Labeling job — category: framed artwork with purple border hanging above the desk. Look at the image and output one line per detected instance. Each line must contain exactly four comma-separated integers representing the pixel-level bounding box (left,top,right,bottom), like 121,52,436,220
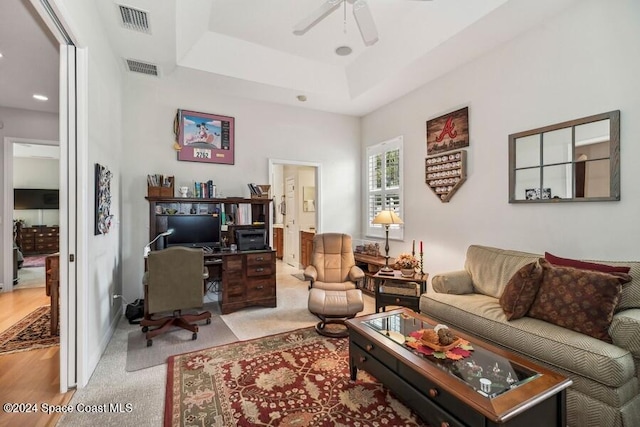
175,110,235,165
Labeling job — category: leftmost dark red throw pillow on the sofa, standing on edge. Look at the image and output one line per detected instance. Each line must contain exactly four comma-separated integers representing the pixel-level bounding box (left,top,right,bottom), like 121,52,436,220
500,261,543,320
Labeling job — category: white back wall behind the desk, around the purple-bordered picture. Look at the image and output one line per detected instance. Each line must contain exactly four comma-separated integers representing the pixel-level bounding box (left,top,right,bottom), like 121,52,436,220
121,69,361,300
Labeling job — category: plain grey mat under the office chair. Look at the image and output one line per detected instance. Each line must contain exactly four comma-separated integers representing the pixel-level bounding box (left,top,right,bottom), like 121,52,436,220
125,315,238,372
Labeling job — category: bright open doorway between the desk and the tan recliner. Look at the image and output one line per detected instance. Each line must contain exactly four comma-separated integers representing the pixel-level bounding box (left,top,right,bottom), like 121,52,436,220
269,159,322,269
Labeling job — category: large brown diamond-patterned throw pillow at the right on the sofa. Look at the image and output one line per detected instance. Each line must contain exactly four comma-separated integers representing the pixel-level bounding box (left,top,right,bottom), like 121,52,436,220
528,259,624,342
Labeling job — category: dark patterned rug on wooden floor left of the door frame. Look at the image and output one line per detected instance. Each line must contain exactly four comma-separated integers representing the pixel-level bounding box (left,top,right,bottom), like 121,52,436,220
0,305,60,355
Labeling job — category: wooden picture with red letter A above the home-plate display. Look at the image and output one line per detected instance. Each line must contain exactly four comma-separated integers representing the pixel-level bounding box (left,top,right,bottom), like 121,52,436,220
427,107,469,156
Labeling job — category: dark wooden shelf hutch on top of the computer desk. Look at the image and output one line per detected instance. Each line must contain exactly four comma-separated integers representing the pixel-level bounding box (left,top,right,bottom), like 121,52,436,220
146,197,273,249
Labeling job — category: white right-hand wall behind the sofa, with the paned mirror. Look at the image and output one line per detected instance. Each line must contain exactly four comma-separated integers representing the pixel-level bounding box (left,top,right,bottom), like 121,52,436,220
362,0,640,275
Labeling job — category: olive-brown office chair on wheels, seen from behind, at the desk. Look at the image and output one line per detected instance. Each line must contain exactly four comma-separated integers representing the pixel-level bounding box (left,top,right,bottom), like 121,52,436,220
140,246,211,346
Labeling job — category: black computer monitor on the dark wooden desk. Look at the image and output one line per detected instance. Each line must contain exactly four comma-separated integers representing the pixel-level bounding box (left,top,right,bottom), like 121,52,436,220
165,215,220,248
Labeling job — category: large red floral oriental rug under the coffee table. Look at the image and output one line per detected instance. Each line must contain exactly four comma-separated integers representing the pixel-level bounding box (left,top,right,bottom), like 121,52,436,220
164,328,424,426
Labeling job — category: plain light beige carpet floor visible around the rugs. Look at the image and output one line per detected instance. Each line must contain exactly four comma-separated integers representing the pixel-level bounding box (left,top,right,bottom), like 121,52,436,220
58,261,375,427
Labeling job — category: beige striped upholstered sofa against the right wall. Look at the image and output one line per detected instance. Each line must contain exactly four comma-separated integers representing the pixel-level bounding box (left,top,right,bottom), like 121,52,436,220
420,245,640,427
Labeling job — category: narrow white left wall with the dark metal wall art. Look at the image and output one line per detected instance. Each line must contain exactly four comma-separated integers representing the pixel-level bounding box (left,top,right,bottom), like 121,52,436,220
55,0,124,387
